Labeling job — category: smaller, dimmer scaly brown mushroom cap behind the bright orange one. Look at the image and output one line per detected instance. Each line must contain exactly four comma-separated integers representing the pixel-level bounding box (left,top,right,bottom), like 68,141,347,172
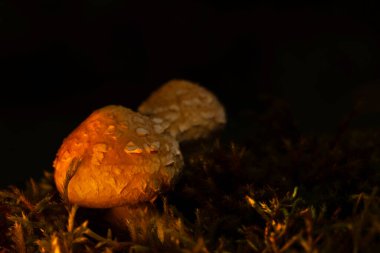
138,79,226,142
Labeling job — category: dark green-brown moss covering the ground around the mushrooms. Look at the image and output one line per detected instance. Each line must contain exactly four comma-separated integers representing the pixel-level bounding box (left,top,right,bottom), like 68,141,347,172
0,98,380,253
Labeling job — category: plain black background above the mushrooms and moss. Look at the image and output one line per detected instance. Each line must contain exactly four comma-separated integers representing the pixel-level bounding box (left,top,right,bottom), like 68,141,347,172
0,0,380,187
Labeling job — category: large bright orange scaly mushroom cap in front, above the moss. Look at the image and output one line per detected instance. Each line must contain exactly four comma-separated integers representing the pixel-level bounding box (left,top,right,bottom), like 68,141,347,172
53,105,183,208
